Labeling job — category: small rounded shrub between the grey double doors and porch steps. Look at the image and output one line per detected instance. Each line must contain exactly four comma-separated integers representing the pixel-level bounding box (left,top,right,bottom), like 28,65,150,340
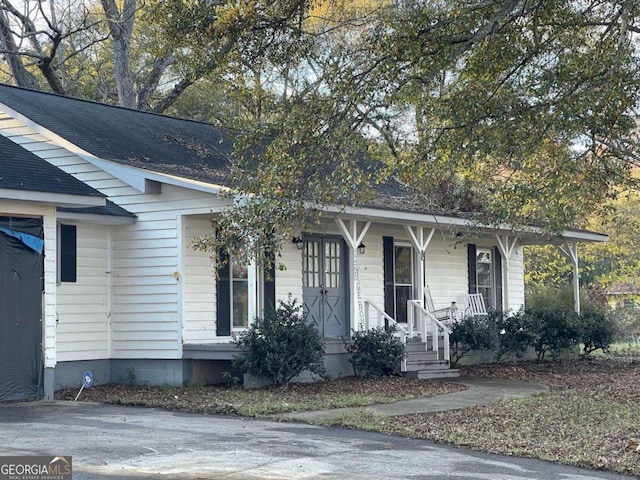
345,327,406,379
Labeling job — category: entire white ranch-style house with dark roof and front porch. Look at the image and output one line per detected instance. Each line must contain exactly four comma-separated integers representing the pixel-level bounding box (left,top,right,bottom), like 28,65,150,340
0,85,606,401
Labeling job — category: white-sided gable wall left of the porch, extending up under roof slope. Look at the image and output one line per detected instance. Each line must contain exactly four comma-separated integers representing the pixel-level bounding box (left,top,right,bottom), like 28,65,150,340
0,114,231,358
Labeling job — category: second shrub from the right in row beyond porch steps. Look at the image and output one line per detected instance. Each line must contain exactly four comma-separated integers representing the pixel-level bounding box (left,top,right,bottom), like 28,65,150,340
525,308,580,361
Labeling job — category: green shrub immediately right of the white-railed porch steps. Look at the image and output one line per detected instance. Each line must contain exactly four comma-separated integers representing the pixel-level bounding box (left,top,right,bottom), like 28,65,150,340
449,316,497,366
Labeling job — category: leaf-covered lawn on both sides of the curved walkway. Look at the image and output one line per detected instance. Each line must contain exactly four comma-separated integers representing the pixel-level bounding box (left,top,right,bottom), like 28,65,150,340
57,353,640,476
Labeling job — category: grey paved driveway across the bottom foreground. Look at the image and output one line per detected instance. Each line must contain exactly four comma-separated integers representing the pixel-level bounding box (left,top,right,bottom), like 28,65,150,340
0,402,630,480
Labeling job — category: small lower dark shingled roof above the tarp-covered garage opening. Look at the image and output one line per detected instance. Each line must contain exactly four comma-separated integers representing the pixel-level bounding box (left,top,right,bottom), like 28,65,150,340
0,135,104,197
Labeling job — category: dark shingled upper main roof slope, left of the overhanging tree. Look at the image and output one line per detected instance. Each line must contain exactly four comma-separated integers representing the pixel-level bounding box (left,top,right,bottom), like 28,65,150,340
0,84,233,185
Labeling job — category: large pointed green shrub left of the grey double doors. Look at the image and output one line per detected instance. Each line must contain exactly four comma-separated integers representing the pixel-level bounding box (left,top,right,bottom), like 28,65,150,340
233,297,325,386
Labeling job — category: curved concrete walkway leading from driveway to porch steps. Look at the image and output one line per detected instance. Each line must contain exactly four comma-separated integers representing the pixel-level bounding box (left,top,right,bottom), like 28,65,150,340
273,378,549,423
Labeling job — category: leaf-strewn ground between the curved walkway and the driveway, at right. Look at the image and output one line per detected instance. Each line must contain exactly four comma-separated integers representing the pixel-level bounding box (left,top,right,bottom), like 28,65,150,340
370,359,640,475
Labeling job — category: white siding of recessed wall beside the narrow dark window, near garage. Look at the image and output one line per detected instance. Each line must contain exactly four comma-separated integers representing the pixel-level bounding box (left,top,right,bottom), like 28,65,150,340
56,224,110,361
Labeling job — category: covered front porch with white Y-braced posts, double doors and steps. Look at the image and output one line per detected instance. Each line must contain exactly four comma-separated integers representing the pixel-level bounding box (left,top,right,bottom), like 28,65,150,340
182,209,606,382
